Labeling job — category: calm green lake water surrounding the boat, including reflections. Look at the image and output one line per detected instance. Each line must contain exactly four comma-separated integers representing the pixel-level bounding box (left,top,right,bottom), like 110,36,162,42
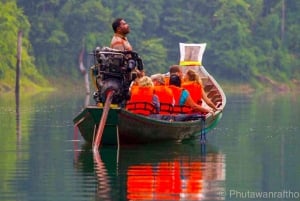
0,90,300,201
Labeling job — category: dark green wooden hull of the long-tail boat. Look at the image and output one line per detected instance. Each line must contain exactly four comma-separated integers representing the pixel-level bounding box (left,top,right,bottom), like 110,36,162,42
74,106,221,145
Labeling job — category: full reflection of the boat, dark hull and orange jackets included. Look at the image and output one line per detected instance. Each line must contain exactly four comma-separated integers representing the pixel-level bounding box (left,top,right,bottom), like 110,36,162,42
75,144,225,200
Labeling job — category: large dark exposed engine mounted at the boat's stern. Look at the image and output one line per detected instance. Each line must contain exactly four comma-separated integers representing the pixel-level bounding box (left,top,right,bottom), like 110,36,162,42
91,47,143,107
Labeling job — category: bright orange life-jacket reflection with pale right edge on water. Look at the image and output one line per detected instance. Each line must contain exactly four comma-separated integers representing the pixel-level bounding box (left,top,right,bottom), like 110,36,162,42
127,154,225,200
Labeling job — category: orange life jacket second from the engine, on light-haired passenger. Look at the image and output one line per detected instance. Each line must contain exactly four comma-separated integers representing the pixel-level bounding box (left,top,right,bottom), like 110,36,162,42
154,86,174,114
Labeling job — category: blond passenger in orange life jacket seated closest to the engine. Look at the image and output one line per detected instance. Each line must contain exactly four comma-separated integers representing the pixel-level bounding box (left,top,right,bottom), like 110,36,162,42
126,76,160,115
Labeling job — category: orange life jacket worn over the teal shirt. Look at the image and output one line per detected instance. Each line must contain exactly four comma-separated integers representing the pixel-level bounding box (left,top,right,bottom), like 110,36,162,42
169,85,192,114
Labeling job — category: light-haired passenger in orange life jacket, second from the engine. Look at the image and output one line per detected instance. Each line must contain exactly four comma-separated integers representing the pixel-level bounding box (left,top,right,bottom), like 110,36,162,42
151,74,175,114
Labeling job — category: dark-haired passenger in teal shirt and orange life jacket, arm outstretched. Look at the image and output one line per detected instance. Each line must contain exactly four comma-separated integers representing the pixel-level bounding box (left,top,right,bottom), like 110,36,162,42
169,65,214,114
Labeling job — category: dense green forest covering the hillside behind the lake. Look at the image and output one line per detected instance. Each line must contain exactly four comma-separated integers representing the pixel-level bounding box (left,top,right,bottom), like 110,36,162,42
0,0,300,93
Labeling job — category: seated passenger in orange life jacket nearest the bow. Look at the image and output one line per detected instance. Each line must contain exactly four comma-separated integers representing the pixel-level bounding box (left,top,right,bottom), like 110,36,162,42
181,69,217,110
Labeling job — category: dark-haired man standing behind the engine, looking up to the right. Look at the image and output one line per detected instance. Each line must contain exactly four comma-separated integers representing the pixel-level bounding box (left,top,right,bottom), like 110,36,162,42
110,18,132,51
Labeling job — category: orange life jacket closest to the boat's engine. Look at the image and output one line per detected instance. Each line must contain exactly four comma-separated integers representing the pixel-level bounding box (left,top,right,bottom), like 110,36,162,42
126,86,156,115
